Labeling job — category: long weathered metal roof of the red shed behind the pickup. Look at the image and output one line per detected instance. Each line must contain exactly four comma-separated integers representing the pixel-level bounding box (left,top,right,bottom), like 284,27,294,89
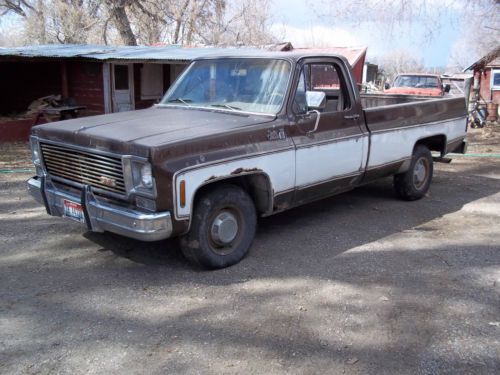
0,44,366,65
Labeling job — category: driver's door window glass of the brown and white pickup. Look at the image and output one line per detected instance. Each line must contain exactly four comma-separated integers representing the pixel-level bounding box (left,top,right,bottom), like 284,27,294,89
310,63,351,112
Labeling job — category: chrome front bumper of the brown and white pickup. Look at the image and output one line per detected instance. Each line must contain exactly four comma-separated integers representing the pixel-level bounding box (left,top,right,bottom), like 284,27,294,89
28,176,172,241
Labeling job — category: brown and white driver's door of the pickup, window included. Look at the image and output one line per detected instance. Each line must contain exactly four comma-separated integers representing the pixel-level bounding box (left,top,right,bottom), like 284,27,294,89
291,58,368,204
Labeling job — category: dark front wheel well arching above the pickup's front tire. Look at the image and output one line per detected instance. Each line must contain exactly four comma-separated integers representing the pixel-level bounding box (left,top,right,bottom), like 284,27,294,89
194,173,273,214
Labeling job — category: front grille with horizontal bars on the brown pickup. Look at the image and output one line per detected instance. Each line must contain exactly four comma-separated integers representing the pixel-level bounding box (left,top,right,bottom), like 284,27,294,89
40,143,126,195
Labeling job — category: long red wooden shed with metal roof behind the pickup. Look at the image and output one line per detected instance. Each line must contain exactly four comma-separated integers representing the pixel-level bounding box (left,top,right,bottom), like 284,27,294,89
0,43,366,142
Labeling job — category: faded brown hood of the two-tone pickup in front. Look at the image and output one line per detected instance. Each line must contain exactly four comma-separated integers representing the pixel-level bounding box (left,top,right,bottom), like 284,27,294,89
32,107,274,156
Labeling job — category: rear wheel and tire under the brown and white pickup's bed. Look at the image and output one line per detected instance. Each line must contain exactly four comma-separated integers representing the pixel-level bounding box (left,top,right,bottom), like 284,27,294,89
394,145,433,201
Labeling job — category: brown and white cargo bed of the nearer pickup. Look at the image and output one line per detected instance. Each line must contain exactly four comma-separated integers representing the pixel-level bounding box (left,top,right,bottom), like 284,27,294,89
362,95,467,175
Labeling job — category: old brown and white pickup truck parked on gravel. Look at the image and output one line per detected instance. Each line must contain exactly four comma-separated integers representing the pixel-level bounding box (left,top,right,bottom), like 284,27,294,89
28,52,467,268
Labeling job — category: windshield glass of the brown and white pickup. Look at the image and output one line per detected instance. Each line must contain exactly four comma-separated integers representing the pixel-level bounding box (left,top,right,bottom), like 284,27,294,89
161,58,291,114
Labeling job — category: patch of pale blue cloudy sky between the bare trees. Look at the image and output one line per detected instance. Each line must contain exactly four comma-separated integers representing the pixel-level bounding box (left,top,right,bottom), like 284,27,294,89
271,0,460,67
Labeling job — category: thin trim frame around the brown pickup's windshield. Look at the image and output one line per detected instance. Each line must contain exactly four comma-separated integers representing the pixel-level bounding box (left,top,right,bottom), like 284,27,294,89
160,56,294,117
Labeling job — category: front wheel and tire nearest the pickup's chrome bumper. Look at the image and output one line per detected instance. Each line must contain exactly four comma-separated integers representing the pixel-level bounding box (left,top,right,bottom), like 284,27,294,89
180,184,257,269
